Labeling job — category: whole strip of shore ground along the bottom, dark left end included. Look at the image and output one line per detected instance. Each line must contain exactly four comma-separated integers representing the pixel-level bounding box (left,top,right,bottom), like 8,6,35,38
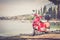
0,34,60,40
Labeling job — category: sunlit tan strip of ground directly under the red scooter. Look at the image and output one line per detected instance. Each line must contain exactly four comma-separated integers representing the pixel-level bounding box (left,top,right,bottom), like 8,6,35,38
20,34,60,39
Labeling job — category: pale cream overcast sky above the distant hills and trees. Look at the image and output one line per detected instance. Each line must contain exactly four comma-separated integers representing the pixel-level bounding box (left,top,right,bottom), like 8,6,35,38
0,0,54,16
